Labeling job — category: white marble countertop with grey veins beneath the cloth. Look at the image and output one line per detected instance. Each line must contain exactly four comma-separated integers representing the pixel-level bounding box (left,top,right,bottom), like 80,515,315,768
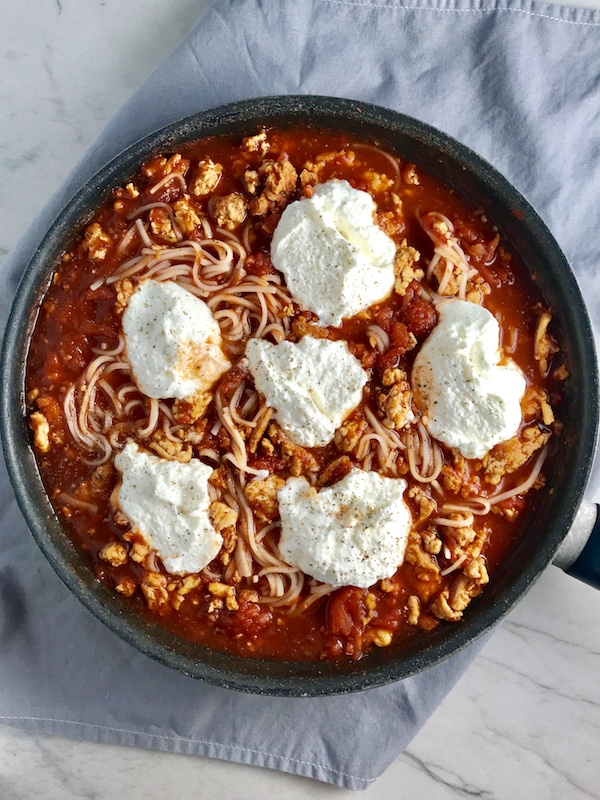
0,0,600,800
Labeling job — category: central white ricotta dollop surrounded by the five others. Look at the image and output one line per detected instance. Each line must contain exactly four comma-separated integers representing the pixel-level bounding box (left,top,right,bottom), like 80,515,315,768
246,336,367,447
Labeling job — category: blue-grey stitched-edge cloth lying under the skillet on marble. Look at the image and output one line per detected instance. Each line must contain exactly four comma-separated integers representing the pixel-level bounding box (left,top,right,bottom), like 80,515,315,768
0,0,600,789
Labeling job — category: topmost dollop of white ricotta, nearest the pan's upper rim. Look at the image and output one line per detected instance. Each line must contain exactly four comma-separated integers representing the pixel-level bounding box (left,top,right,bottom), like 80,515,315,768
271,180,396,325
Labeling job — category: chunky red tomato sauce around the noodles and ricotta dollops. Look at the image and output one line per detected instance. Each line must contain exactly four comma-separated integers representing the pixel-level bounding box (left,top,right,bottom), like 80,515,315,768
27,129,560,660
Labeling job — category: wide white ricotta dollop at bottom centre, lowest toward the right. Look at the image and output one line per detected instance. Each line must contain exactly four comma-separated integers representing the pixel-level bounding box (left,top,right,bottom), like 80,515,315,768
278,469,412,589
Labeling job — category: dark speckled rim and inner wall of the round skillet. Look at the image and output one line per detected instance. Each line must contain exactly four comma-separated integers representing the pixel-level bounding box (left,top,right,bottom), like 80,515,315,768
0,96,598,696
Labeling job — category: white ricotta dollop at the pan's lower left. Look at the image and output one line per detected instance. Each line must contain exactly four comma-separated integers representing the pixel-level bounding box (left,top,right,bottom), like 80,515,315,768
115,442,223,575
